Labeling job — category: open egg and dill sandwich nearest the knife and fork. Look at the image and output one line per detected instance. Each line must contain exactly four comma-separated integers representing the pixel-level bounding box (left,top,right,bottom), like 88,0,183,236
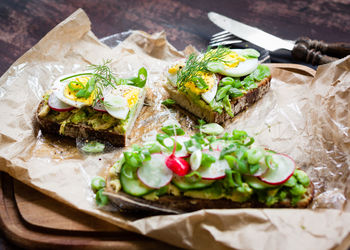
165,47,271,123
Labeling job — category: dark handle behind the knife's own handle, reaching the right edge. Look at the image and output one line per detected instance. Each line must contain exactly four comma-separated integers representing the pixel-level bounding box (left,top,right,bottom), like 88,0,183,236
296,37,350,58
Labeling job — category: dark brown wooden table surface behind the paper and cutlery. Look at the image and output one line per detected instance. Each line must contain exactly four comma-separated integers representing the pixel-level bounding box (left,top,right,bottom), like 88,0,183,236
0,0,350,249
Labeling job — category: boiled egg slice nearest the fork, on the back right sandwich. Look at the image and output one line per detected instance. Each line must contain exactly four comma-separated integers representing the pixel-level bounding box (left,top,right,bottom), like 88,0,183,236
208,49,260,77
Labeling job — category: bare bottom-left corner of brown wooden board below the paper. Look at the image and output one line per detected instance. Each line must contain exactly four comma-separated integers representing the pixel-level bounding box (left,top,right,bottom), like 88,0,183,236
0,173,176,249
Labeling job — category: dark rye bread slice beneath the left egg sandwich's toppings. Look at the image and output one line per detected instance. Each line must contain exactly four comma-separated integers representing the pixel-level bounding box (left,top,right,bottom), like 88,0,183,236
36,90,146,147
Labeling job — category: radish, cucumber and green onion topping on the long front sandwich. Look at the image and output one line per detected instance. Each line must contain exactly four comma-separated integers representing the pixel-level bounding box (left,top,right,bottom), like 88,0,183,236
111,122,310,206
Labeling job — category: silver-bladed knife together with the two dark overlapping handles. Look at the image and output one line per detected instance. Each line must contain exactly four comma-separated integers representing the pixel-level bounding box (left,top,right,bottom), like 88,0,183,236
208,12,350,65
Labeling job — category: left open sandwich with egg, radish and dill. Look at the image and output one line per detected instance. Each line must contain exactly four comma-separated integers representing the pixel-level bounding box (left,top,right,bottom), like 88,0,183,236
37,63,147,146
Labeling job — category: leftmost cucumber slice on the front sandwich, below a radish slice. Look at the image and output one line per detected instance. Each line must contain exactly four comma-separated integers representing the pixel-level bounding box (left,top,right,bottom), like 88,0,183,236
120,165,153,196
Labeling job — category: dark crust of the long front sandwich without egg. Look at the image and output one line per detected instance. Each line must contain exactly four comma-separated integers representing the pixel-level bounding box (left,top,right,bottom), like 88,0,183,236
106,183,314,213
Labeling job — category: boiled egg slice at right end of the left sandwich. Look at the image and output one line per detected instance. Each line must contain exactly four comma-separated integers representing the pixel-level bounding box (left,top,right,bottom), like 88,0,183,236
103,85,141,120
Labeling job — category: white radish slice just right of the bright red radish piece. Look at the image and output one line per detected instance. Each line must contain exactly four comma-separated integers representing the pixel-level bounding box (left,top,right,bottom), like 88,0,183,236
197,151,230,180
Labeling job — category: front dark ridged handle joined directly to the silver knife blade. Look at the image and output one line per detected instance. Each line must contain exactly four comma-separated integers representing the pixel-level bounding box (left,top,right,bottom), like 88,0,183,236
292,43,338,65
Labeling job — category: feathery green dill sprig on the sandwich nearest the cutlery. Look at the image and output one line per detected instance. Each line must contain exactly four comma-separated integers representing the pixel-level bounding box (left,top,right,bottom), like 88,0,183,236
177,47,230,91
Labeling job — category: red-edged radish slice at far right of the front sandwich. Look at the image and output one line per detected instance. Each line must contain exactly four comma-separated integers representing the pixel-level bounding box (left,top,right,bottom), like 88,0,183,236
258,154,295,185
